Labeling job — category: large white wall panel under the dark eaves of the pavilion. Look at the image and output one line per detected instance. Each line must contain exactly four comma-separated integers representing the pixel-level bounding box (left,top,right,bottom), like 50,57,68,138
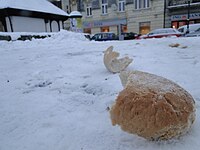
10,16,46,32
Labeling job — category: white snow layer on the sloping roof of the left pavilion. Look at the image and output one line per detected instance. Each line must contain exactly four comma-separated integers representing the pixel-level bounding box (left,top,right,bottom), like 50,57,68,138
0,0,69,16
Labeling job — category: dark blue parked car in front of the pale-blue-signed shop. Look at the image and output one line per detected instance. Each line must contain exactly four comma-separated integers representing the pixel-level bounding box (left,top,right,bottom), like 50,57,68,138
91,32,118,41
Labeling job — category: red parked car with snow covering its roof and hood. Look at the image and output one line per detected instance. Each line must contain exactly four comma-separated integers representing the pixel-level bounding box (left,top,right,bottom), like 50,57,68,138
138,28,183,39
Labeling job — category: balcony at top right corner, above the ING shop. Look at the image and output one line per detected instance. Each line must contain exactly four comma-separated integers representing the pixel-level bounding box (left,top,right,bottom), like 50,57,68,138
168,0,200,9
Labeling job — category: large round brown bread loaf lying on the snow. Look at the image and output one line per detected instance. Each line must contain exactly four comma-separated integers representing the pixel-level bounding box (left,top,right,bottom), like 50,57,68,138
110,71,195,140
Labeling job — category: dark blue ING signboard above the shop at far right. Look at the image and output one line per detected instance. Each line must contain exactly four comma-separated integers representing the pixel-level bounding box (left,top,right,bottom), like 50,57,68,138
171,13,200,21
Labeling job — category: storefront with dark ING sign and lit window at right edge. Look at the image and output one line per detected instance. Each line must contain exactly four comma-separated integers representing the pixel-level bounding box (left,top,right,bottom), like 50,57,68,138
171,13,200,28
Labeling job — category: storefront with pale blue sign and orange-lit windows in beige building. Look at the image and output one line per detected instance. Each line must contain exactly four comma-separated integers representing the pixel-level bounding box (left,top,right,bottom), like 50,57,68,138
83,19,127,34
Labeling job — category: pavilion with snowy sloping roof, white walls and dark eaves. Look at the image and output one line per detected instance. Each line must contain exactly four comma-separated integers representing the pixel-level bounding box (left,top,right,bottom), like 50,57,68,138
0,0,69,32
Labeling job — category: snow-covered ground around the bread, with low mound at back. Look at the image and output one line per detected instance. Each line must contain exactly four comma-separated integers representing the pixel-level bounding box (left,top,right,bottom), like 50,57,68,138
0,31,200,150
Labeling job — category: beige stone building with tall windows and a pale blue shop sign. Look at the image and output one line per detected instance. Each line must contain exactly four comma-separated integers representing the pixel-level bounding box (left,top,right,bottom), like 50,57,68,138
69,0,164,34
